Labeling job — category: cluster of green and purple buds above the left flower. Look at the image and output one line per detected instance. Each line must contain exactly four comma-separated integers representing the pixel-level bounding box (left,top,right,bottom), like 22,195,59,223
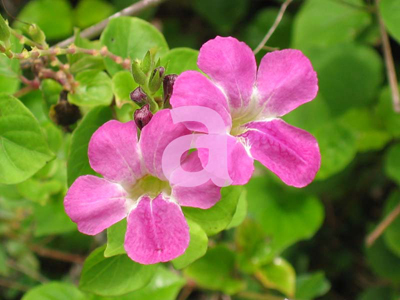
130,49,177,129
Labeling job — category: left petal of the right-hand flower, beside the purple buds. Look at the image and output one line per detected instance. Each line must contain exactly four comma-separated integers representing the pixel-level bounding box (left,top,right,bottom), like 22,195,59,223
170,71,232,132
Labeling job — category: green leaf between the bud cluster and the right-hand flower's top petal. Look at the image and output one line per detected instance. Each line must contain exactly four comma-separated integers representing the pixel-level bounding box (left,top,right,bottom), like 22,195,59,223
161,48,200,75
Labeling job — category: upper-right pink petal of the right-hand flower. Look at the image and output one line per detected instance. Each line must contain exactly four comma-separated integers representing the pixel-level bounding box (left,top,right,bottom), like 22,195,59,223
257,49,318,117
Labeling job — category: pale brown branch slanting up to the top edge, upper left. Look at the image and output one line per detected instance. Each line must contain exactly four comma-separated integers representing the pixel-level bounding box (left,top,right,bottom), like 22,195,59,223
56,0,165,47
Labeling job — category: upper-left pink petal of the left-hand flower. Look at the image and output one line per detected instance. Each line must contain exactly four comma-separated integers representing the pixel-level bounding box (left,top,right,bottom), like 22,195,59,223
88,120,144,184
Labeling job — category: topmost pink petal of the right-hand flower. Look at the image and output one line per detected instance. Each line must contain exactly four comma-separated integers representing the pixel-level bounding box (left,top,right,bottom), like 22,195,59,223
197,36,257,109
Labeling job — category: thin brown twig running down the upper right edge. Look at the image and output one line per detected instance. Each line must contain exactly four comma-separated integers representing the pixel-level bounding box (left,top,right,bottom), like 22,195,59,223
375,0,400,113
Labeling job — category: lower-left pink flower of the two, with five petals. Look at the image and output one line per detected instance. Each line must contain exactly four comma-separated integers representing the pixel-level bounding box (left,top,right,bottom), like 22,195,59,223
64,110,221,264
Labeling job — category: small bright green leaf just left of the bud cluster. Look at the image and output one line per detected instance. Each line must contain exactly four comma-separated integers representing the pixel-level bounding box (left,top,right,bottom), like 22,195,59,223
112,71,138,107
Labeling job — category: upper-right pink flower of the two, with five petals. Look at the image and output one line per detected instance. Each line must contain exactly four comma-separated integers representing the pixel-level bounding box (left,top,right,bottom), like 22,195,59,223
170,37,321,187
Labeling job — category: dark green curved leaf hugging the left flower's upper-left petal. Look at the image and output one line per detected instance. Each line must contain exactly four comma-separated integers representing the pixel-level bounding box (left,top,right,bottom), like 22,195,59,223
67,107,112,186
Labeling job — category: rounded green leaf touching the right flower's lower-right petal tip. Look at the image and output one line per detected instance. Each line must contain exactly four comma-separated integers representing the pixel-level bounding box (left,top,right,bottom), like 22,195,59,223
314,121,357,179
